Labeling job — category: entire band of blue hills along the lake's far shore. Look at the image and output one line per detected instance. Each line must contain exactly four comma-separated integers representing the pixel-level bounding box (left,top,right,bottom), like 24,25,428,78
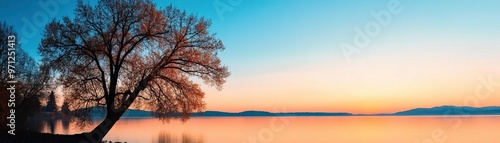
71,106,500,118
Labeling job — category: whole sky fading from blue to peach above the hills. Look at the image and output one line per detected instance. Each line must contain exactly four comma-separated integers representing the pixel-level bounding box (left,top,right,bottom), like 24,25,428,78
0,0,500,113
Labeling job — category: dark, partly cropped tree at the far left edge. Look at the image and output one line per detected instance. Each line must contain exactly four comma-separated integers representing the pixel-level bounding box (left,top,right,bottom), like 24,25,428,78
0,22,49,130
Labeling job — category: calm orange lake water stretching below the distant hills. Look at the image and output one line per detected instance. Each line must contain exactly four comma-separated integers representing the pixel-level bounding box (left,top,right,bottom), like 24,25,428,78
42,116,500,143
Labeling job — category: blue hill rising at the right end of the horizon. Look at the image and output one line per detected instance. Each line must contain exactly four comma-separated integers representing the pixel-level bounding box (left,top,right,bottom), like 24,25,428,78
392,106,500,115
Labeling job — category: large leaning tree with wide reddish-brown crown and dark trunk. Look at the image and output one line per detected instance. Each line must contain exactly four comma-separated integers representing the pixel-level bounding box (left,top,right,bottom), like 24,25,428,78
39,0,230,140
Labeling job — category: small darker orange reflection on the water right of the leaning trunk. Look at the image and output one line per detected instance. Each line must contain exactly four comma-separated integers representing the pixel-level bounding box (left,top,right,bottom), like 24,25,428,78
153,130,204,143
